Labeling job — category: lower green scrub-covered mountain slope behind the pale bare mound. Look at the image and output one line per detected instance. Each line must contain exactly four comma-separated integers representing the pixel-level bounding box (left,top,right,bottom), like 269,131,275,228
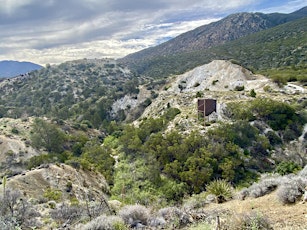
120,17,307,78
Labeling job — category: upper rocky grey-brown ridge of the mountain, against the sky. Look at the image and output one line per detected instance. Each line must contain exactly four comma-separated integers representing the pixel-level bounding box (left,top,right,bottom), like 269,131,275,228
124,7,307,61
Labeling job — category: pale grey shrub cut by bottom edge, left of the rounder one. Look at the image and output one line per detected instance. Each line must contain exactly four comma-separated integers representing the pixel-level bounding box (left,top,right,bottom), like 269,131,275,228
82,215,128,230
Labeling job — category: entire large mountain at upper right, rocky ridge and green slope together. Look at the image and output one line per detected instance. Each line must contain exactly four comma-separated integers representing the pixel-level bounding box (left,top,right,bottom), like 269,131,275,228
120,8,306,78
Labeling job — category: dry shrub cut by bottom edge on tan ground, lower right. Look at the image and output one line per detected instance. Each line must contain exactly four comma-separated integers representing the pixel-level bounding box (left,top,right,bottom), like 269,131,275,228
222,212,272,230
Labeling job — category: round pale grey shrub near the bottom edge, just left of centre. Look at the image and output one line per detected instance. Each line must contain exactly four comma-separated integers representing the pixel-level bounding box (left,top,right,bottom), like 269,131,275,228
119,204,150,227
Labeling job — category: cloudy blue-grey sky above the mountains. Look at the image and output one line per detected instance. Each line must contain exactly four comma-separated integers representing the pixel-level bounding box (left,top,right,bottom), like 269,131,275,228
0,0,307,65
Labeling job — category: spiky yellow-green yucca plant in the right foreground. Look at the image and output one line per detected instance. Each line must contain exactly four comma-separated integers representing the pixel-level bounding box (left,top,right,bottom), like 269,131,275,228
206,179,233,203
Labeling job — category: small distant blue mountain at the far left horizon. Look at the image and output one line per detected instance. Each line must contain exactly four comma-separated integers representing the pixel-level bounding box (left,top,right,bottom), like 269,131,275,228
0,61,42,78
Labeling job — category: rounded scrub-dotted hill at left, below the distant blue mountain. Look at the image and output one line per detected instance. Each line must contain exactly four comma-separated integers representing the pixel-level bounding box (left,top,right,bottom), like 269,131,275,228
0,59,153,128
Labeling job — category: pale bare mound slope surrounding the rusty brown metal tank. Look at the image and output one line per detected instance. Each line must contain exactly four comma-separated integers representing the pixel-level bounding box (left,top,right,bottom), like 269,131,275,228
140,60,307,132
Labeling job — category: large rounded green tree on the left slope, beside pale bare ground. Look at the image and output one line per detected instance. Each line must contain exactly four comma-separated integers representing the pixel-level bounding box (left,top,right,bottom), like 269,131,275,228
31,118,65,153
